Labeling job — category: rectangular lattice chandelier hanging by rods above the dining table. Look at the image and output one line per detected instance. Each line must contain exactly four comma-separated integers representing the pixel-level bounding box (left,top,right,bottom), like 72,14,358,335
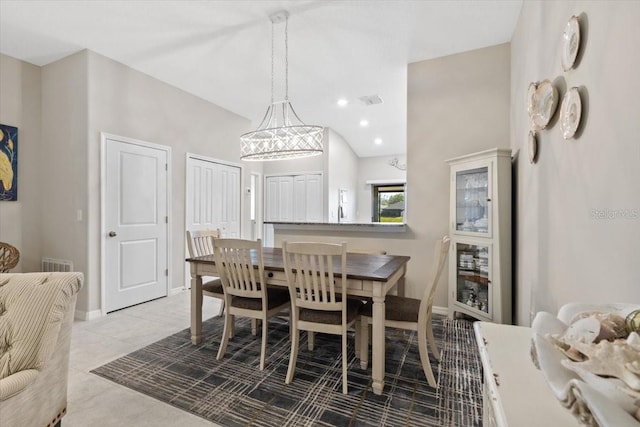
240,11,324,161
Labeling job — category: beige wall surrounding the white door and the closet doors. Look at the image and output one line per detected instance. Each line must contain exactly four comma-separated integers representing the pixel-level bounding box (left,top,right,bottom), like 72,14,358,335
85,52,255,311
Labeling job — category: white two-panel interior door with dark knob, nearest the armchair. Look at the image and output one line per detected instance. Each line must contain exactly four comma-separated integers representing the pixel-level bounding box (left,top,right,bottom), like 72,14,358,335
102,136,169,312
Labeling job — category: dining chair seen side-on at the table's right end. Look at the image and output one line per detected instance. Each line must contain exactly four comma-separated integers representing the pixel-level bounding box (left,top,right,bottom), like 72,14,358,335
360,236,451,388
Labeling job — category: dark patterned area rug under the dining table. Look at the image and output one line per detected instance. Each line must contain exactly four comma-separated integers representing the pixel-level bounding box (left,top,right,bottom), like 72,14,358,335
92,316,482,427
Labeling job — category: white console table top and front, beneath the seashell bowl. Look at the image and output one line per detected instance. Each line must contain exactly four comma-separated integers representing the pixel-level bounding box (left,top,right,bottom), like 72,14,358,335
473,322,579,427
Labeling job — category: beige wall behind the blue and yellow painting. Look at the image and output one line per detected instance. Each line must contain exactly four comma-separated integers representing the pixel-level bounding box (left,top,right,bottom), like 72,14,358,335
0,55,41,271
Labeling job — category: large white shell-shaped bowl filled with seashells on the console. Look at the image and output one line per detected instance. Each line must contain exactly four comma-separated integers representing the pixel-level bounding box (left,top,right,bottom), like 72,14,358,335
531,303,640,427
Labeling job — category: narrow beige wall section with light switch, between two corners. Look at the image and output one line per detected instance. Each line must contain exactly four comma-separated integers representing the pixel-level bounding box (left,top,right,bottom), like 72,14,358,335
39,54,90,307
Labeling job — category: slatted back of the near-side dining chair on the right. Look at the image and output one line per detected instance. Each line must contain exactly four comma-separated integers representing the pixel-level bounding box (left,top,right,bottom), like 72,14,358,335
282,241,347,317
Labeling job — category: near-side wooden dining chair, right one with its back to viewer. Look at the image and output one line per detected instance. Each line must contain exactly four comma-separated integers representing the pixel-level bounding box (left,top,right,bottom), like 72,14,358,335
282,241,363,394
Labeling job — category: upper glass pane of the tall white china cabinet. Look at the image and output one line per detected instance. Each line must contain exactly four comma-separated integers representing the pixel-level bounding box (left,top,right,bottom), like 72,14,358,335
455,166,491,235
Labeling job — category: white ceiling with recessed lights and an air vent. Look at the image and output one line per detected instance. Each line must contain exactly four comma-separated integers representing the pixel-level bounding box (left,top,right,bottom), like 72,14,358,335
0,0,522,157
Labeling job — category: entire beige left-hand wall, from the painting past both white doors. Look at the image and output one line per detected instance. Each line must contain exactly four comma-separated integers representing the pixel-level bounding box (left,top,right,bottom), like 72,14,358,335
0,51,262,316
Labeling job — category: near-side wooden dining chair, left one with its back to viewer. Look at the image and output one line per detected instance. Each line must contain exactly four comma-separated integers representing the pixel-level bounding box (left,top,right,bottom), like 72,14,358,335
213,239,290,371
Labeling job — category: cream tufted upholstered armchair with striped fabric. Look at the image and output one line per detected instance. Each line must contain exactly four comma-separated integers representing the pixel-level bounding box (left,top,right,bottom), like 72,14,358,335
0,273,83,427
